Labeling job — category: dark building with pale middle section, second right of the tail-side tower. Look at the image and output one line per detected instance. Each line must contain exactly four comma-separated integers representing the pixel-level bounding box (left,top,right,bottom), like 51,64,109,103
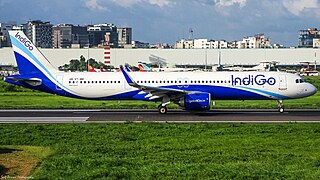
87,24,118,48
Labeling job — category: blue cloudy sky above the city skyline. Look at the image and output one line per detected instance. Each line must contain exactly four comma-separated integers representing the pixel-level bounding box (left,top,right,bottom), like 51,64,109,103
0,0,320,46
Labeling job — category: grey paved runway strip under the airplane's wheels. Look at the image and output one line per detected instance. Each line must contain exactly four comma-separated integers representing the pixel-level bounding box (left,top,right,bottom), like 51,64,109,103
0,109,320,123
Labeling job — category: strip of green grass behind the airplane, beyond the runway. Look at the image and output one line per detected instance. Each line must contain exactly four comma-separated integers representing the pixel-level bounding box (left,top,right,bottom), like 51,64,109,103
0,77,320,109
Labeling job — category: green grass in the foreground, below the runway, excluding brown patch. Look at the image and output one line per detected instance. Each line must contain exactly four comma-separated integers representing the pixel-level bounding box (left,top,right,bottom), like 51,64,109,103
0,123,320,179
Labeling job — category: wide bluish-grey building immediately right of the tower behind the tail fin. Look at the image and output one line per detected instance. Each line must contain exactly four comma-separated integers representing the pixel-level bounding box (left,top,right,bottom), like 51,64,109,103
53,24,89,48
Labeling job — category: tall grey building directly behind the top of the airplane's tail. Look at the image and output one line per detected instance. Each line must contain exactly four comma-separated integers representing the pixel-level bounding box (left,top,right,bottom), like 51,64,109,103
25,20,53,48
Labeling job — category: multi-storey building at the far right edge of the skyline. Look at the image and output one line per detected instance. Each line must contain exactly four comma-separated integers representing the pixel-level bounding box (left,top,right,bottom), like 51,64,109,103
298,28,320,48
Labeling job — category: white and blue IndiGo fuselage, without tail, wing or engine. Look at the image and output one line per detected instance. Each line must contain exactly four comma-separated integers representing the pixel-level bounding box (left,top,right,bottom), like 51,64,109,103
56,72,316,100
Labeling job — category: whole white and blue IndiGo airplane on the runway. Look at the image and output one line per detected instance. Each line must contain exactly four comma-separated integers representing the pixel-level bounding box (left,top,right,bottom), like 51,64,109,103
5,31,317,114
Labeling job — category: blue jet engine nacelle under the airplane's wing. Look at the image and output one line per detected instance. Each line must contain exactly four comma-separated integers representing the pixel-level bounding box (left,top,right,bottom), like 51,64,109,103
179,93,211,111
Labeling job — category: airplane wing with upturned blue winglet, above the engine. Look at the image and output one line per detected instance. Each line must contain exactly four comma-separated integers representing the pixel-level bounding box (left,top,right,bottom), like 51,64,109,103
120,66,194,100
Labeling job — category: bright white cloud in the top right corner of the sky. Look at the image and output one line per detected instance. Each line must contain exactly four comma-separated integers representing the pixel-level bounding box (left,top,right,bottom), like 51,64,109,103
282,0,320,16
